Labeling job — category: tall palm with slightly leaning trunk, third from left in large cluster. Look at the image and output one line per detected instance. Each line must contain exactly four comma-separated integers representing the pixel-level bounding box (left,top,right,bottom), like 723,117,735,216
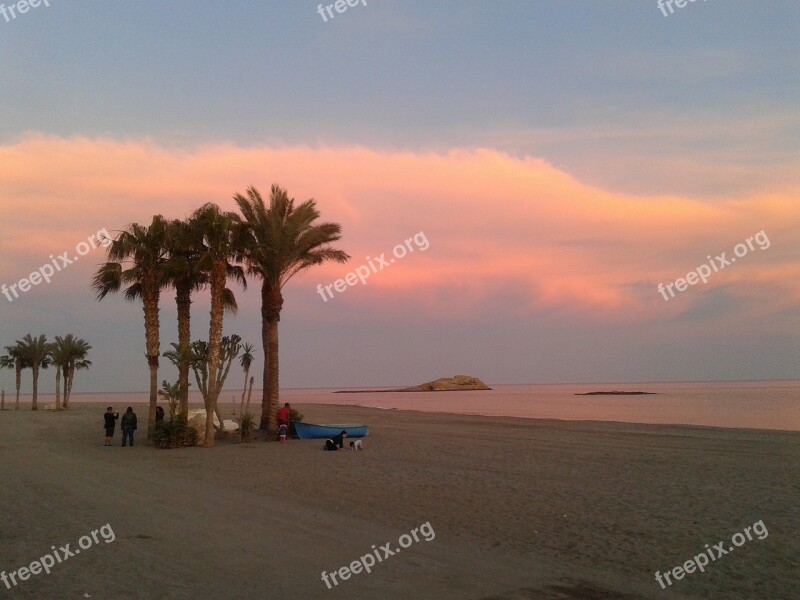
190,203,247,447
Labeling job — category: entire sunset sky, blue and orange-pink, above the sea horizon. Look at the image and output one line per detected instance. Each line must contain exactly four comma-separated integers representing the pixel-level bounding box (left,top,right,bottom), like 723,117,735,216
0,0,800,394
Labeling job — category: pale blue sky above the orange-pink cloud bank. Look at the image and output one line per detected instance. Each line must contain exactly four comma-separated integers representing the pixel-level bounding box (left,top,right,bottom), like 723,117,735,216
0,0,800,193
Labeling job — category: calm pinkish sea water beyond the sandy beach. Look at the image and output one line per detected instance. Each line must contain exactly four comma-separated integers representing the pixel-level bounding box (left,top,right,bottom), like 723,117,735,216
26,381,800,431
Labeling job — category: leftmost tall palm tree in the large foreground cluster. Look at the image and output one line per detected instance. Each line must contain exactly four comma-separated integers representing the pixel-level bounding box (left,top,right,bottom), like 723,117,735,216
92,215,168,444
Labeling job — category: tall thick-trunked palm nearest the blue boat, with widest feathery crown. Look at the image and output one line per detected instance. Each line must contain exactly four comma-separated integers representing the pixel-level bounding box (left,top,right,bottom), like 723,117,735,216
234,185,350,434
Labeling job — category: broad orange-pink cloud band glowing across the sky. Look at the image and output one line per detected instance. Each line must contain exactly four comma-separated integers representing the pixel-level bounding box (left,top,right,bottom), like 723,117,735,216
0,134,800,320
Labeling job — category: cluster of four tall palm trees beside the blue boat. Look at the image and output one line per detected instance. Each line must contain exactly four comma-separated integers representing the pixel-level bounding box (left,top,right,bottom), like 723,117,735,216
92,185,350,446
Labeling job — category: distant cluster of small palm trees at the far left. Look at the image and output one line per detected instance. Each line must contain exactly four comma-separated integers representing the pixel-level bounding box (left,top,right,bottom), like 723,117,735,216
0,333,92,410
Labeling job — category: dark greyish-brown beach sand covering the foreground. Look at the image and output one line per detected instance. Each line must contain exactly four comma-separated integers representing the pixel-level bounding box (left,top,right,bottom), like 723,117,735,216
0,404,800,600
